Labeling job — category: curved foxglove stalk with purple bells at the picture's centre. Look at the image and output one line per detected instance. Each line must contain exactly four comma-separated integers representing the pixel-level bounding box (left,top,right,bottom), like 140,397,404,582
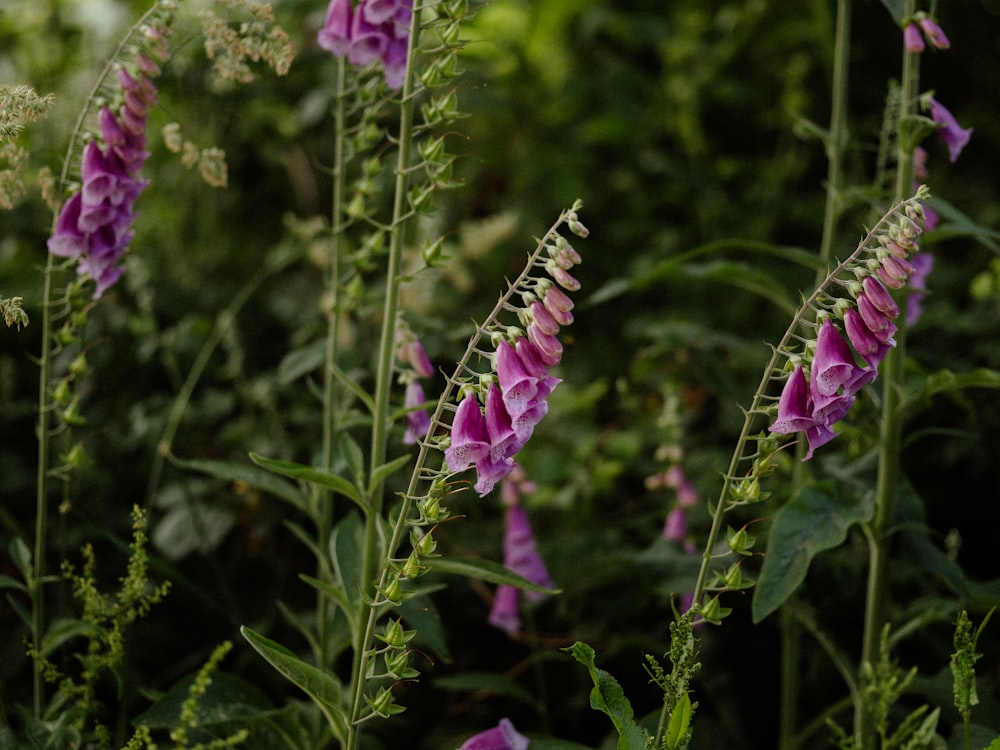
347,202,588,747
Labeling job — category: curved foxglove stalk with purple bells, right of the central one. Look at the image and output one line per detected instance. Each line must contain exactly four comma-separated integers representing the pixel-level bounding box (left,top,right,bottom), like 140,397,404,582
694,187,928,623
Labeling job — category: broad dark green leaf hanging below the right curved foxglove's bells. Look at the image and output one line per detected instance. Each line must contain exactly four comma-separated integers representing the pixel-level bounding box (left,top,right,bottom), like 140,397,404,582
752,482,873,623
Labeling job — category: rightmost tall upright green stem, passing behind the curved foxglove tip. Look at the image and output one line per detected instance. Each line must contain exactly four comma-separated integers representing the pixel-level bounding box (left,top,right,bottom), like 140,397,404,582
854,0,919,748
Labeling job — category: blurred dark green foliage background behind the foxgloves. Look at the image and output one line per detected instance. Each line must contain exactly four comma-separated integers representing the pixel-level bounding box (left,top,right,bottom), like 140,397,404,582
0,0,1000,748
